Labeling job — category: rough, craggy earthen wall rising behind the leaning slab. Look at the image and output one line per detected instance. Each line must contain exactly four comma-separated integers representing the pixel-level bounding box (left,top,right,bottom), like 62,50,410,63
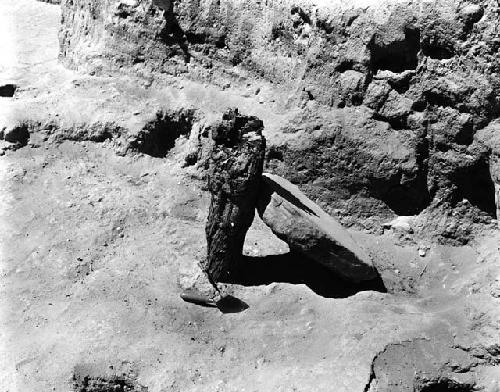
60,0,500,242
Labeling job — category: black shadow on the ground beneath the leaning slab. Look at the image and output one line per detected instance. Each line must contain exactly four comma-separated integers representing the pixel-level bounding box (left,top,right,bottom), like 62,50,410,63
223,252,387,298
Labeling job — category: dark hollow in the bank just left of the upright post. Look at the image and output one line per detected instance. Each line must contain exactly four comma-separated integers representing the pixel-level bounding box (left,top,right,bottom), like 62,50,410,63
130,110,194,158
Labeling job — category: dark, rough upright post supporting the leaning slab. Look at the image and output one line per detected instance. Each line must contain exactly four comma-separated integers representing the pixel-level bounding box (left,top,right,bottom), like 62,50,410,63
202,109,266,284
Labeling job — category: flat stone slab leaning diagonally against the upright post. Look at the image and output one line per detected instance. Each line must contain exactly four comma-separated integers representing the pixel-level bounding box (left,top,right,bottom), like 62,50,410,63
257,173,377,282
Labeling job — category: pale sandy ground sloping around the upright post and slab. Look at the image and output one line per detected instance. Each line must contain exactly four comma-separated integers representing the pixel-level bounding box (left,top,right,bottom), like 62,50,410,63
0,0,500,392
